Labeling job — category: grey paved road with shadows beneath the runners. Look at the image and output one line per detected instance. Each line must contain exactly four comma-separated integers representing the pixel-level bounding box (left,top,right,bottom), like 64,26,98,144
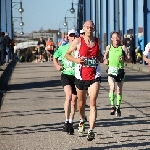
0,63,150,150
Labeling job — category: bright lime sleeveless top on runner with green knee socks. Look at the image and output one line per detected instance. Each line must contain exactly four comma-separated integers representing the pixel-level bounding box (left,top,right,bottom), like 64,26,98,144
108,45,124,75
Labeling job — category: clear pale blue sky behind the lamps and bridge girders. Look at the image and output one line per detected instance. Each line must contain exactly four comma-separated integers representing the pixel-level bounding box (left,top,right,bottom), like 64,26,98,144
12,0,143,33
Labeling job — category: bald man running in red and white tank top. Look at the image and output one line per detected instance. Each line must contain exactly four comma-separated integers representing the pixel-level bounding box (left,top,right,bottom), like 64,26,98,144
66,20,101,141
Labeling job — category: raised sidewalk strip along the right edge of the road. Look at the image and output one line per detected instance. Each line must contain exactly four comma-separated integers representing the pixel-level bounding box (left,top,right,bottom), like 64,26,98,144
125,63,150,73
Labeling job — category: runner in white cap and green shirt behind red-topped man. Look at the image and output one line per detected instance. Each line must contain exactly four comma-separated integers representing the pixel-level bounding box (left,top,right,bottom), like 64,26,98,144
53,29,77,134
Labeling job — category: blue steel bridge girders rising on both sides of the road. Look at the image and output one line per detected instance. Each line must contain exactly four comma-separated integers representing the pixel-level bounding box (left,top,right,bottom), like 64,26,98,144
0,0,150,54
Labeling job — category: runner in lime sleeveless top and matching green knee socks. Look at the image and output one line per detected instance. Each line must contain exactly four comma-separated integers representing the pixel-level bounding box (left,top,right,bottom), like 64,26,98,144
104,31,129,116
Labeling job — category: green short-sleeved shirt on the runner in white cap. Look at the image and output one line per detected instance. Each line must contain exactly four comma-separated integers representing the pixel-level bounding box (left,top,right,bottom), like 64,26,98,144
54,44,75,76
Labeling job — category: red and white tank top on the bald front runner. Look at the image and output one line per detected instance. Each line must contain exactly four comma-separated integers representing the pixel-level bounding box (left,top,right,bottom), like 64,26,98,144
75,37,101,80
